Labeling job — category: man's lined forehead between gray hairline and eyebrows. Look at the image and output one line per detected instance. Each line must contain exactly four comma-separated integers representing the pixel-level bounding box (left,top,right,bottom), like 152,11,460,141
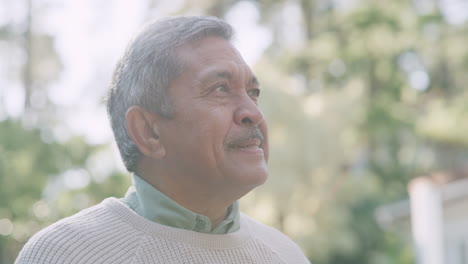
177,36,253,78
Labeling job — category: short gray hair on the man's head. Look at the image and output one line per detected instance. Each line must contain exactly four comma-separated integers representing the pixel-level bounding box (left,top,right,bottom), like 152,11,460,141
107,16,233,172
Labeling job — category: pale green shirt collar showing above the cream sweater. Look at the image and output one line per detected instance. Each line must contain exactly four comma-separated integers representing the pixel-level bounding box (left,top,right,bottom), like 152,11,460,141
122,175,240,234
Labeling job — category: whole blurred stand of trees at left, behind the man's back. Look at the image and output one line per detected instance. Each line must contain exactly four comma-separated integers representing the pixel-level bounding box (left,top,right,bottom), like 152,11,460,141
0,0,130,263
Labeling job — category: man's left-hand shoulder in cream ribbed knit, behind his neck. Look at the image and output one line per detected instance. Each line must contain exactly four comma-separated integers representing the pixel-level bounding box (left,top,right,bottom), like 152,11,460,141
15,198,144,264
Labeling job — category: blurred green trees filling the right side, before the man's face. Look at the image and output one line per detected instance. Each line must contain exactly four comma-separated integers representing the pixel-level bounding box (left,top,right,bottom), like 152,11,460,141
229,0,468,263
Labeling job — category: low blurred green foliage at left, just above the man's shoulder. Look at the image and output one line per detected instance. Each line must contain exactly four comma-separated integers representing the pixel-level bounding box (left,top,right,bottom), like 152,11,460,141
0,119,130,263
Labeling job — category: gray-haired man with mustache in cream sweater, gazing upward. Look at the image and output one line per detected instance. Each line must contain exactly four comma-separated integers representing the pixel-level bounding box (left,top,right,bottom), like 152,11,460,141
17,17,308,264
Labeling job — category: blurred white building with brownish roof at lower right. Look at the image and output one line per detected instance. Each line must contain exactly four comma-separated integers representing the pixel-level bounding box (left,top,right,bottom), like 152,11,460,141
376,170,468,264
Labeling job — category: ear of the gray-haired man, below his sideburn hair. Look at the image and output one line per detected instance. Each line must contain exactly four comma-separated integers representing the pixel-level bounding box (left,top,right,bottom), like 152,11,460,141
125,106,166,159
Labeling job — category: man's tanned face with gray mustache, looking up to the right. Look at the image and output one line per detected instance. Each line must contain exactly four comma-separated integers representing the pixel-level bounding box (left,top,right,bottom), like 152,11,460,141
160,37,268,193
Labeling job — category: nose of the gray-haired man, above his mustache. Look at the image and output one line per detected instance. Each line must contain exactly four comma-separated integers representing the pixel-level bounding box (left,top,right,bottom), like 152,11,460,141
234,95,264,126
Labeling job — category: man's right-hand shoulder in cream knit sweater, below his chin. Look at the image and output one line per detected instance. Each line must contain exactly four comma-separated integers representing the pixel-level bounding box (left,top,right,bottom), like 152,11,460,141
241,213,309,263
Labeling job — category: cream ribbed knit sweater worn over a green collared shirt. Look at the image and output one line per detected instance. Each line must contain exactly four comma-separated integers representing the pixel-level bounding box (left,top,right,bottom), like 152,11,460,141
15,198,309,264
